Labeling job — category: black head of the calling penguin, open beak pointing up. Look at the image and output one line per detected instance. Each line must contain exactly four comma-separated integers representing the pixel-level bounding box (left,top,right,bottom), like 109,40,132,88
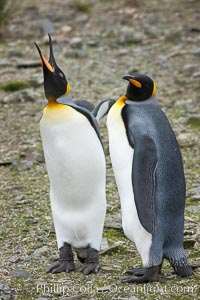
35,34,70,100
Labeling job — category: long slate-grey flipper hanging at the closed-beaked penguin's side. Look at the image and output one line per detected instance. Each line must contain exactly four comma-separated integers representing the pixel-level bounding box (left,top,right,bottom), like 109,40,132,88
132,136,157,233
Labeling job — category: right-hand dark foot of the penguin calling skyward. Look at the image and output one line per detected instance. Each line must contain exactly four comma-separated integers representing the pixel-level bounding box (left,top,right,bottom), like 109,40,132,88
82,247,99,275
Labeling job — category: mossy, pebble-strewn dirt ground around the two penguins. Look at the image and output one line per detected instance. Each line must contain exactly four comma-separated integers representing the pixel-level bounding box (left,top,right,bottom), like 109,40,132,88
0,0,200,300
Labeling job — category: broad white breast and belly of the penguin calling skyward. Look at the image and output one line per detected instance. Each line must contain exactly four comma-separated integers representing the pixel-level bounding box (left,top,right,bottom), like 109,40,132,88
40,107,106,250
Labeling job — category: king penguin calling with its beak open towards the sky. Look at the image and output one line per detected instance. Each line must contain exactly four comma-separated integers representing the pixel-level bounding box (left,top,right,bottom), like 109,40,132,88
35,35,106,275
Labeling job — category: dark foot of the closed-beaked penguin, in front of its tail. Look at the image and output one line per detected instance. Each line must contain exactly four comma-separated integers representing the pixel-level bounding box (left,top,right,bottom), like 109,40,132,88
121,266,160,283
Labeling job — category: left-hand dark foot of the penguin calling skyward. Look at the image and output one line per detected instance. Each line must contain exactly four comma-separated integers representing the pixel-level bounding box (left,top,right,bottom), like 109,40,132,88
47,243,75,274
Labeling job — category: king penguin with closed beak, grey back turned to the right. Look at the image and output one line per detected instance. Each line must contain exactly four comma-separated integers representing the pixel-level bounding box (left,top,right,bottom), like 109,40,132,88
107,74,192,283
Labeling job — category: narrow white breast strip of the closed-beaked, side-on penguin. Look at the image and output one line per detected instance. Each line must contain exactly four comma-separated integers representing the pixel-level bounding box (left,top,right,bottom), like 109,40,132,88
107,104,152,266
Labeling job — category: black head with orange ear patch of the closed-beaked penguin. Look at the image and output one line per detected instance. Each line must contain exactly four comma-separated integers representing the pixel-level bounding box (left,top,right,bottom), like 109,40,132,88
122,74,156,101
